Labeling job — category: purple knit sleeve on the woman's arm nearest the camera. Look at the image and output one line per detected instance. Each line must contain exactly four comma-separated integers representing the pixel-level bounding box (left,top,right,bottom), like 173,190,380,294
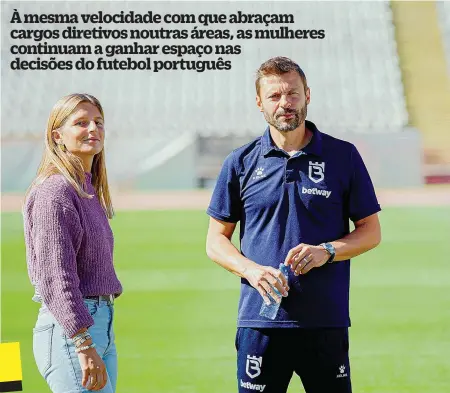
30,189,94,337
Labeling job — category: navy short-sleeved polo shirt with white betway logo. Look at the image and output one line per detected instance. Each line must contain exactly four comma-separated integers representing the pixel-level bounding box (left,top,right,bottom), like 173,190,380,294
207,121,380,328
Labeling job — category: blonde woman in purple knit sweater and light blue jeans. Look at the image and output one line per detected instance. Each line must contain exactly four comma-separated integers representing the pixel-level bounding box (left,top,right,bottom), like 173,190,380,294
24,94,122,393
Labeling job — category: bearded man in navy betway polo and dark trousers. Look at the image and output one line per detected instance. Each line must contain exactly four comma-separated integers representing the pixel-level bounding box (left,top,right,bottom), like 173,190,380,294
207,57,381,393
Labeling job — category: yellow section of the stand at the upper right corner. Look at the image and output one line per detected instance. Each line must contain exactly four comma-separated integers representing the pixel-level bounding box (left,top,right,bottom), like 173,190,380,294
392,2,450,183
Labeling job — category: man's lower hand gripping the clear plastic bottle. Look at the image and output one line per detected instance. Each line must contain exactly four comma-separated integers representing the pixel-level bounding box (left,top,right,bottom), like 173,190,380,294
243,263,289,305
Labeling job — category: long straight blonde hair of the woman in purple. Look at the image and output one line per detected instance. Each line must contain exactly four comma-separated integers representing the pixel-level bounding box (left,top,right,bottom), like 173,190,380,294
27,94,114,218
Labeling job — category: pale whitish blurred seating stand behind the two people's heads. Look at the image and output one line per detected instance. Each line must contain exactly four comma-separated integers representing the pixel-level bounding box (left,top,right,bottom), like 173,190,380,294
2,2,407,136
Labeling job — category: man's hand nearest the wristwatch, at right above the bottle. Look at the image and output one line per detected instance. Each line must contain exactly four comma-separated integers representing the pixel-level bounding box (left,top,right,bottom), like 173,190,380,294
284,243,330,276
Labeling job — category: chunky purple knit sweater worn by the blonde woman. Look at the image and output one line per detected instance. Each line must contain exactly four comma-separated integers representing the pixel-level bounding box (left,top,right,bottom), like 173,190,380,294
24,173,122,337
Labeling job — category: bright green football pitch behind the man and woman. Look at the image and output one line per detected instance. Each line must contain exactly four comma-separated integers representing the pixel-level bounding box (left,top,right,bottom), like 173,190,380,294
1,207,450,393
